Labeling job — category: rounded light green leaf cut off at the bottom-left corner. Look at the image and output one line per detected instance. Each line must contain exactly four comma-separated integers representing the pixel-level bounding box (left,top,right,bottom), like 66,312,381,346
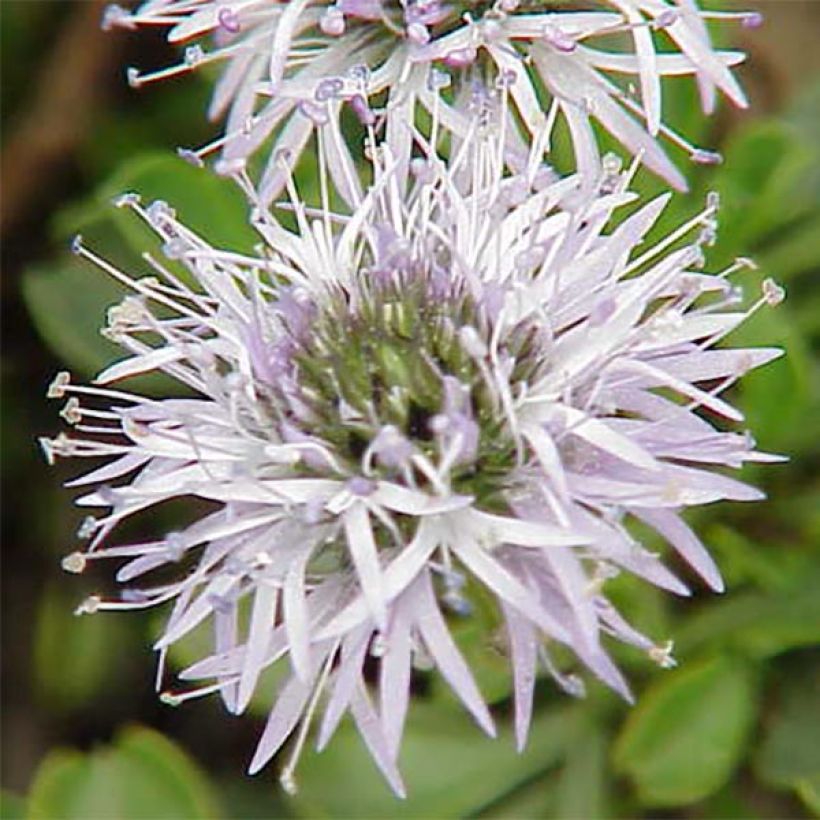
28,726,220,820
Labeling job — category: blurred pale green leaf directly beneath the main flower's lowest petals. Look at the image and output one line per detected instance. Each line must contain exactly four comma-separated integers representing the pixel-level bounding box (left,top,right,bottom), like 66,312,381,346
292,703,576,818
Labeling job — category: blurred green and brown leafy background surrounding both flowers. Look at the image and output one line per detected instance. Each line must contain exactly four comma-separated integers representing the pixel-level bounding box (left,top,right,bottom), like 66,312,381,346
0,0,820,820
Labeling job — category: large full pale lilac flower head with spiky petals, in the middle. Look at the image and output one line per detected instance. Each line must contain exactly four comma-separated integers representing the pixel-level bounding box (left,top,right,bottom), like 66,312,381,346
49,121,783,795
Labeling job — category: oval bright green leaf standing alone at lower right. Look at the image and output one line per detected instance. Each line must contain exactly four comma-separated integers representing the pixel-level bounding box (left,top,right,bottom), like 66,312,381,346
614,658,755,806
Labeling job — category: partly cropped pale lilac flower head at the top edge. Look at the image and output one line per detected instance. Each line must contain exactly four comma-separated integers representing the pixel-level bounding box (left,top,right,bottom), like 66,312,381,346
105,0,759,202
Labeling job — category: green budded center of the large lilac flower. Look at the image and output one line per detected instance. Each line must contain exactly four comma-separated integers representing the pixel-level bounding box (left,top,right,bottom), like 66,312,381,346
294,276,539,507
